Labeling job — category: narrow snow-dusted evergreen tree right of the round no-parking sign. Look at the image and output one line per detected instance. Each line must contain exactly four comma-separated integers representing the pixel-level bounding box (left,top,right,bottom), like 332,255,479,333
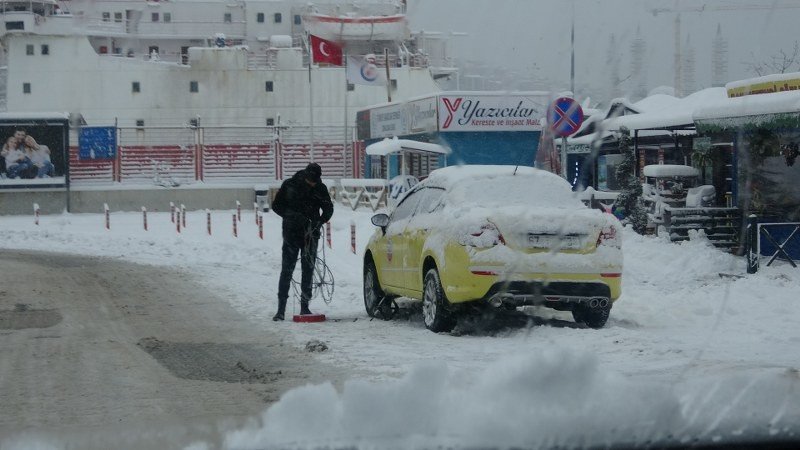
616,127,647,234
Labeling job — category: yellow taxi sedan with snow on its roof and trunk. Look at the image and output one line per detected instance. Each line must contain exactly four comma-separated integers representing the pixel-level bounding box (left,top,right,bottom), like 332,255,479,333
364,165,623,332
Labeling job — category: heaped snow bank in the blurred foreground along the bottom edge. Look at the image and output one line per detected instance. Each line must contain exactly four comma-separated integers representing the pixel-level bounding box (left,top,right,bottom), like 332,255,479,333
224,348,800,449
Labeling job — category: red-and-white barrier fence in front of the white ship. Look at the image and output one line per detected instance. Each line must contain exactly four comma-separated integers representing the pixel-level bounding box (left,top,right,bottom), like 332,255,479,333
69,127,356,186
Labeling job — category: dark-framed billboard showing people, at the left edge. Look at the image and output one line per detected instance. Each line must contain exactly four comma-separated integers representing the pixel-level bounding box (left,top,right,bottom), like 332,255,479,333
0,116,69,188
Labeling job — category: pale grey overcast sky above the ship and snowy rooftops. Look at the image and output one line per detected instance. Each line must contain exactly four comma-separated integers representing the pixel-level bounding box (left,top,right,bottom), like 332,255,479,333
408,0,800,99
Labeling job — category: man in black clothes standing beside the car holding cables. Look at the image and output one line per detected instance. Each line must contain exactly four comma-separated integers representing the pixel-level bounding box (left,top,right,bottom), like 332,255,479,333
272,163,333,321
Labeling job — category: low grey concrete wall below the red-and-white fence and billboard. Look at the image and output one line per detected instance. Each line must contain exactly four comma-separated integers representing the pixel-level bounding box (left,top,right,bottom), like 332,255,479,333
0,187,266,215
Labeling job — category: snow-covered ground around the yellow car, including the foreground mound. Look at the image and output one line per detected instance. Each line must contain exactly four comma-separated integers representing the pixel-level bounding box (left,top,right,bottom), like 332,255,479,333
0,205,800,448
